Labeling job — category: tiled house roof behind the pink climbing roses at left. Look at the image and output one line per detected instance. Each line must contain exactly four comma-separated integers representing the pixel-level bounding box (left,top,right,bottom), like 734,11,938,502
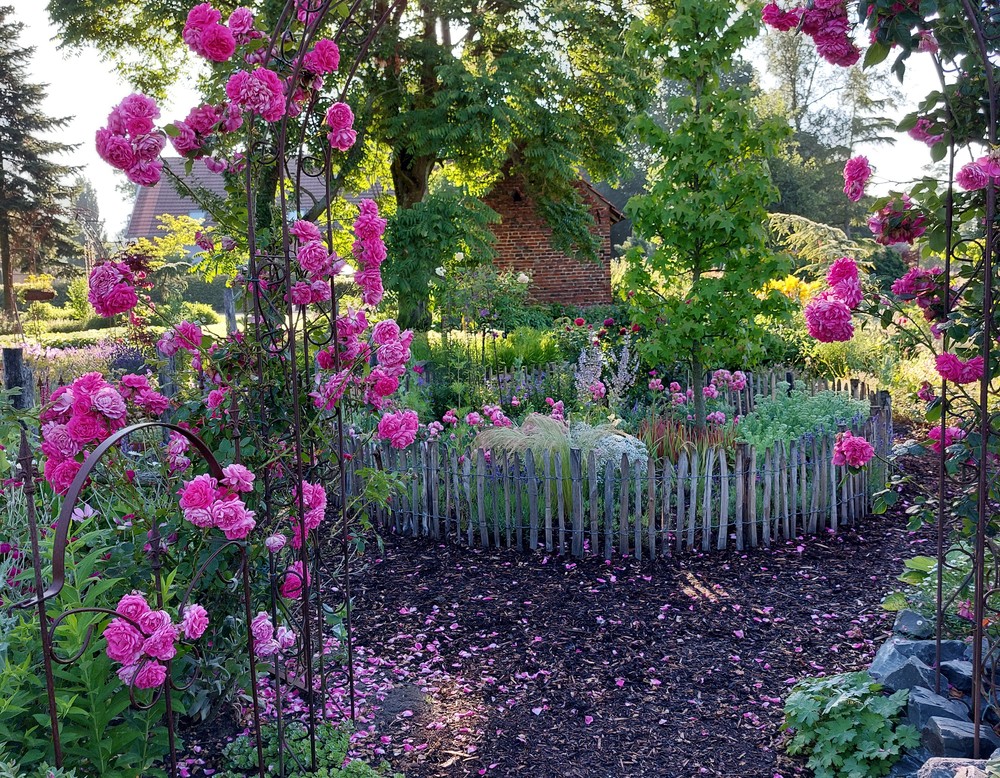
125,157,371,240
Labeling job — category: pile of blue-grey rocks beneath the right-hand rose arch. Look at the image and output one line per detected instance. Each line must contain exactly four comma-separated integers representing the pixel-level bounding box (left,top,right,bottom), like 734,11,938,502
880,610,1000,778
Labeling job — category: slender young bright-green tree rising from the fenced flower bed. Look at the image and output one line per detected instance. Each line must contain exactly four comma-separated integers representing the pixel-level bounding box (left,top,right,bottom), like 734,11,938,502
625,0,788,425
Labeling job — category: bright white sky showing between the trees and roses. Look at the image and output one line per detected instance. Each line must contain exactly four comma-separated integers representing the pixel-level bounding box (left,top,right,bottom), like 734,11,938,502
8,0,936,239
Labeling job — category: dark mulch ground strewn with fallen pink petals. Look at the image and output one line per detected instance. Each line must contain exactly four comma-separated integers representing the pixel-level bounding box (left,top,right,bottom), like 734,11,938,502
355,448,929,778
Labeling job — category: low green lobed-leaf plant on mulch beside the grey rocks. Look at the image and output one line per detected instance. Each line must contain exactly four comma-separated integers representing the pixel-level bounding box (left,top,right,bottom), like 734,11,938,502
784,672,920,778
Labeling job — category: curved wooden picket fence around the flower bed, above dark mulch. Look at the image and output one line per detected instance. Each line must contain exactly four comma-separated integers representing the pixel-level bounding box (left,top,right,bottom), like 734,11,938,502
348,380,893,559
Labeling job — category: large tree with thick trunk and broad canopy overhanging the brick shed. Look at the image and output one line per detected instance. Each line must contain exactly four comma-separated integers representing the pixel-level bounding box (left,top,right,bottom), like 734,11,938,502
49,0,650,327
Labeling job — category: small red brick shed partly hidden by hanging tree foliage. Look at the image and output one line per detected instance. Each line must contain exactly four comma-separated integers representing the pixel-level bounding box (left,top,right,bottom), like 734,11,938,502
485,177,611,305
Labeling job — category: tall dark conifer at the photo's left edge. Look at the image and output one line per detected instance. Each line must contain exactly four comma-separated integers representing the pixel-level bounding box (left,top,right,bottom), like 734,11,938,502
0,6,73,315
